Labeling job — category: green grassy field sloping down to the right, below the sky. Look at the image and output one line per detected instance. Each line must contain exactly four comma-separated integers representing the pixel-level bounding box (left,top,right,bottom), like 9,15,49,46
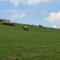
0,25,60,60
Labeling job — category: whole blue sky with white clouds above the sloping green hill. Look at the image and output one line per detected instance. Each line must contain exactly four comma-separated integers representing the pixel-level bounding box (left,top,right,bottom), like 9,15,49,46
0,0,60,28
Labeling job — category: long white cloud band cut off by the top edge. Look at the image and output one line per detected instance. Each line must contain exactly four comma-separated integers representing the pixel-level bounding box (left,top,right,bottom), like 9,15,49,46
10,0,49,7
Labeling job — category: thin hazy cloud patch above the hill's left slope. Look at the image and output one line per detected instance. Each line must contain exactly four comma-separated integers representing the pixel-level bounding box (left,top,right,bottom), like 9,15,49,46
3,10,27,23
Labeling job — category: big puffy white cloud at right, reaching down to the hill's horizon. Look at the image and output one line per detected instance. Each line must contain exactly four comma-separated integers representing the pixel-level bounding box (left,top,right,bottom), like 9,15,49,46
45,12,60,27
